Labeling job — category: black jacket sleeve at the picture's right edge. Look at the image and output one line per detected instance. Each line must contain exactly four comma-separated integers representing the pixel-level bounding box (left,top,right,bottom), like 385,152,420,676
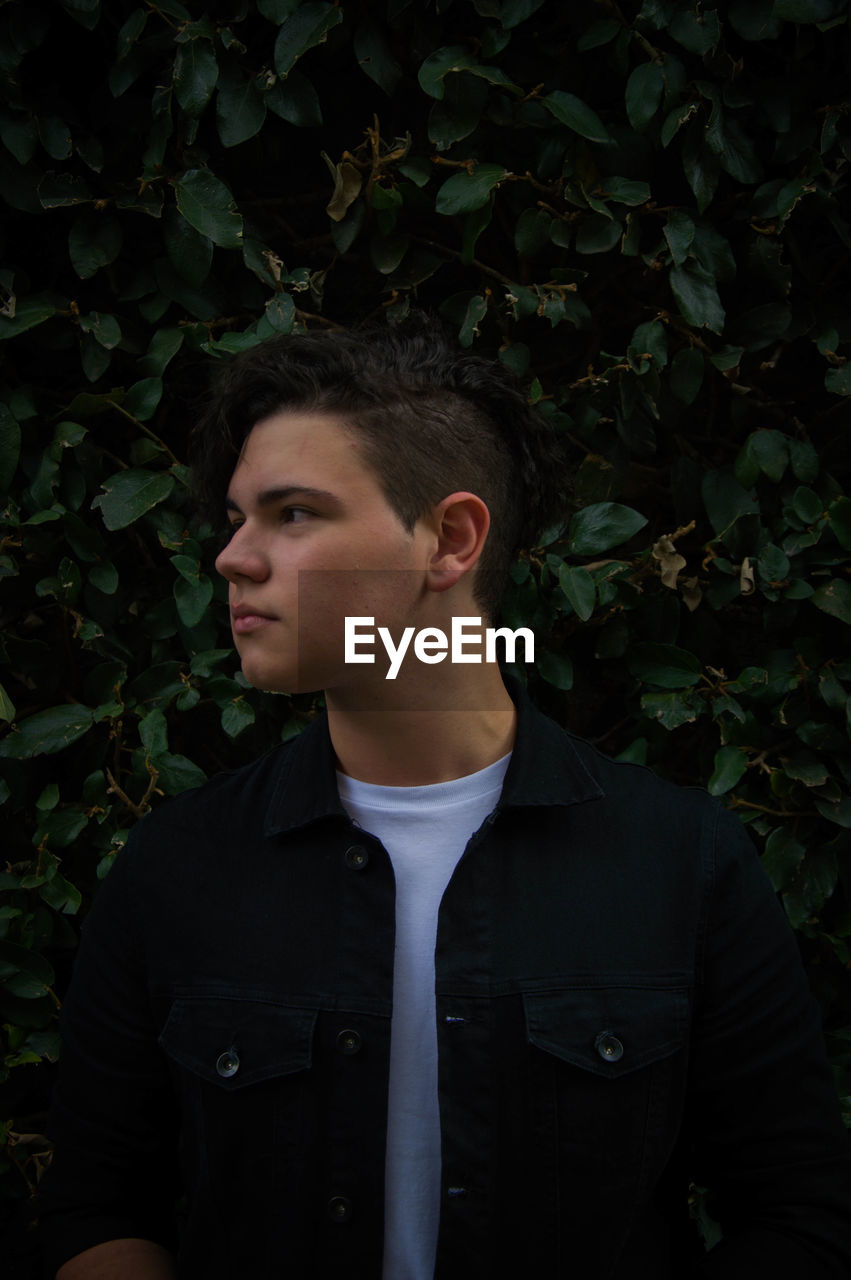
690,808,851,1280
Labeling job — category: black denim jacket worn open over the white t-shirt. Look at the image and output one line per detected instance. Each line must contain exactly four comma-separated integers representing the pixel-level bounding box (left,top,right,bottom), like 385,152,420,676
42,689,851,1280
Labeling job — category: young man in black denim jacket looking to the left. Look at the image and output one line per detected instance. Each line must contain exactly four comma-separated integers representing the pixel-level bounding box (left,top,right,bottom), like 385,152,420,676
44,330,851,1280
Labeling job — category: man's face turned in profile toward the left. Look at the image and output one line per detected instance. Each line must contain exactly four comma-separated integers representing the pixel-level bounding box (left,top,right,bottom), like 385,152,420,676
216,412,435,692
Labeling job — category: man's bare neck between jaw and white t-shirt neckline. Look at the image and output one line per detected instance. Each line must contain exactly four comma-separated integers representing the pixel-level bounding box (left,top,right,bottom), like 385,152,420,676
325,666,517,787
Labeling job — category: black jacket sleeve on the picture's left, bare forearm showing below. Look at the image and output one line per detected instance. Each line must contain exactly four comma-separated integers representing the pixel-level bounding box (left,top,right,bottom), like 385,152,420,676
40,824,178,1276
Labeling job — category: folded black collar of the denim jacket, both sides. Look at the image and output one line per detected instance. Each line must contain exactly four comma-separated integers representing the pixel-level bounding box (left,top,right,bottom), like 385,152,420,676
265,676,604,836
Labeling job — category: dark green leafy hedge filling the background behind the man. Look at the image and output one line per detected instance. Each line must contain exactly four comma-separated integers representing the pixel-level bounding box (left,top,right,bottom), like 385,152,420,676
0,0,851,1256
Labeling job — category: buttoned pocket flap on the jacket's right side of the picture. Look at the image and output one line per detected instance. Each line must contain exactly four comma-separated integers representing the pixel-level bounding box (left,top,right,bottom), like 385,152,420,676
523,987,688,1079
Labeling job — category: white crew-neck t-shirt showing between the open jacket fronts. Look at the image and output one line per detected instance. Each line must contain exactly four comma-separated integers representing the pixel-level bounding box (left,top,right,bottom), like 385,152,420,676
337,755,511,1280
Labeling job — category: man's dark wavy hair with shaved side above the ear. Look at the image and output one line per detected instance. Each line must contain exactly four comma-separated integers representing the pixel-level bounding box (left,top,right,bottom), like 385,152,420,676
192,316,567,618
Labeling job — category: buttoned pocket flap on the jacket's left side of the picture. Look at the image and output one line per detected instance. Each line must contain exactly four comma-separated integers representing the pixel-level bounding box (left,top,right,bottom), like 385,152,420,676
159,998,316,1089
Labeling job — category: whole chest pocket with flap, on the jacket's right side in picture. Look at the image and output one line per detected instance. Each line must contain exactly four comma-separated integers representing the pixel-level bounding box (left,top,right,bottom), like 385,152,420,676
523,986,688,1196
